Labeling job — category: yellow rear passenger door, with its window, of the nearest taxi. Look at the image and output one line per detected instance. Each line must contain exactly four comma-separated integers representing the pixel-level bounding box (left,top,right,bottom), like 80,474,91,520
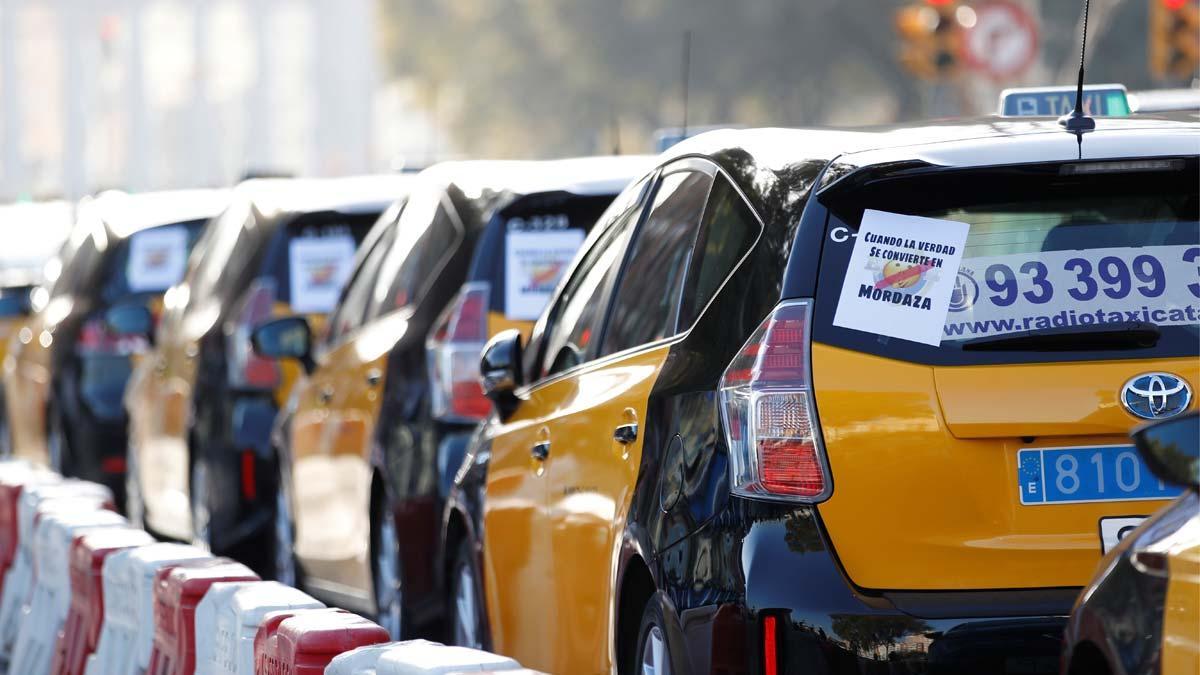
546,162,713,673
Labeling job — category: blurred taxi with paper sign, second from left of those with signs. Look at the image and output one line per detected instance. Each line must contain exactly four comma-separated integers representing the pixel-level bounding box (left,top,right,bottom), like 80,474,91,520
118,177,408,566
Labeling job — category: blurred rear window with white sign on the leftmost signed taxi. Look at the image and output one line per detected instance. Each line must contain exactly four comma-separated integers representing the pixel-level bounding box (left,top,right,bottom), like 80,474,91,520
101,220,205,303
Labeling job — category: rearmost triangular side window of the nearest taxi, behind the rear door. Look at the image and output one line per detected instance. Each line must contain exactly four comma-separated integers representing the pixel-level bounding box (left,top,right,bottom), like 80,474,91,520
679,178,762,328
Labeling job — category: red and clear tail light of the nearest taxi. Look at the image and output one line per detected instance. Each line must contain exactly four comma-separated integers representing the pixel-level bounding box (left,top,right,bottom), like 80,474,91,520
720,300,832,502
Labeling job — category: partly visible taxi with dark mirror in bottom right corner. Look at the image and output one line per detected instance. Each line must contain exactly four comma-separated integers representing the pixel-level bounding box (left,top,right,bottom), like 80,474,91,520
1062,410,1200,675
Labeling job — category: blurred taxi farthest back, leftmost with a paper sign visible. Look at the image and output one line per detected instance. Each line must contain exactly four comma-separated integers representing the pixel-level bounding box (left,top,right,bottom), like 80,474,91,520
4,190,227,503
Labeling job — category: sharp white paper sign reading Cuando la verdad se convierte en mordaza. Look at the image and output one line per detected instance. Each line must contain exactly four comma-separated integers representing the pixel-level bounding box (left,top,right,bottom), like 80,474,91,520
833,210,971,346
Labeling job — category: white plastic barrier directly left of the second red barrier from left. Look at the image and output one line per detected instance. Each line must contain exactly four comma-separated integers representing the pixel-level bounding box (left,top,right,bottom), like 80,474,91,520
8,501,128,675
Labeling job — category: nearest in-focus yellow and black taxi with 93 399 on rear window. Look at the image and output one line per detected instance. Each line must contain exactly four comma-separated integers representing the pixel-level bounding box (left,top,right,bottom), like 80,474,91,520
439,118,1200,675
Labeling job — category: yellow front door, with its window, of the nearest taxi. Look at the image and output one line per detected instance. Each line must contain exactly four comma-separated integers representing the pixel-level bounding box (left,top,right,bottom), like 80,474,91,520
484,171,657,671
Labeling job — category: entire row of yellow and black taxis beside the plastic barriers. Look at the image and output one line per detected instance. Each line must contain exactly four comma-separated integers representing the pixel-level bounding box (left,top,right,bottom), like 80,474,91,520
0,115,1200,675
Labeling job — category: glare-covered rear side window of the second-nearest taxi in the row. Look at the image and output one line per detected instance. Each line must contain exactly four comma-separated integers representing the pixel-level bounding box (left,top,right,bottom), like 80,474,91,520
367,186,462,318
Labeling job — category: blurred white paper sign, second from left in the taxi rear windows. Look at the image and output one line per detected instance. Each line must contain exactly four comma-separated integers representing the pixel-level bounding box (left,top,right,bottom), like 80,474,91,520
288,234,354,313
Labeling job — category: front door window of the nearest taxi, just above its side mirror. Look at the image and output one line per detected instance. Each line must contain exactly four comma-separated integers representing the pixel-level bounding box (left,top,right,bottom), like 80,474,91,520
541,199,641,376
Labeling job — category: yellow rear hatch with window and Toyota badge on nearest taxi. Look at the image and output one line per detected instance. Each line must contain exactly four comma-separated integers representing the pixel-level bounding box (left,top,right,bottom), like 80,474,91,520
812,156,1200,590
